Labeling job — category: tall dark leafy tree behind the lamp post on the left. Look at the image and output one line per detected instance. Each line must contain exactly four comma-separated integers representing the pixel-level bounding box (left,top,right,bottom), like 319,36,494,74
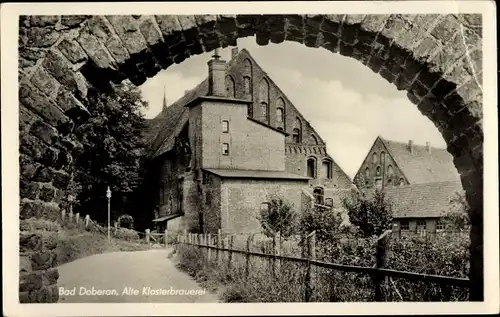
73,82,148,225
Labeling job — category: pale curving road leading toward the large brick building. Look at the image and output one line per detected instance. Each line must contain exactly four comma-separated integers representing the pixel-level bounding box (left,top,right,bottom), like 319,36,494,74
58,249,218,303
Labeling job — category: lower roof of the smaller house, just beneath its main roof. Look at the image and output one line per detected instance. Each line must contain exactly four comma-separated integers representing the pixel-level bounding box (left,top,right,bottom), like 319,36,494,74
374,181,463,218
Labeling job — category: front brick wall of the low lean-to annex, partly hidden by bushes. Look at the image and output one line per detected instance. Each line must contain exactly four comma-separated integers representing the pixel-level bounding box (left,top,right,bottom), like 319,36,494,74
221,179,307,233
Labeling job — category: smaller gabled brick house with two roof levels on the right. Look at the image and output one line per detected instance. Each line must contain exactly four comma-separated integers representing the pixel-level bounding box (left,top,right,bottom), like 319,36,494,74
354,137,463,233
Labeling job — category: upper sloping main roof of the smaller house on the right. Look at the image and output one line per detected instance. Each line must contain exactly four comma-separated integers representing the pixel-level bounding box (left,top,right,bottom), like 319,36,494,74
380,138,460,184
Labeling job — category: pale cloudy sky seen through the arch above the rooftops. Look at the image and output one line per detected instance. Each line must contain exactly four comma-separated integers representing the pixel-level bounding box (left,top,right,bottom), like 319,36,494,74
140,37,446,178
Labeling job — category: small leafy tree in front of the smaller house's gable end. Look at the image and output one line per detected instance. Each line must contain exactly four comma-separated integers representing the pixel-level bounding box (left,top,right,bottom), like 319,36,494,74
343,190,392,237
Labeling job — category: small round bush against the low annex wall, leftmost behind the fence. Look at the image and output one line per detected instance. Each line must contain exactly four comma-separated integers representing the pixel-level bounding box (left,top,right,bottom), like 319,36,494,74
259,196,297,239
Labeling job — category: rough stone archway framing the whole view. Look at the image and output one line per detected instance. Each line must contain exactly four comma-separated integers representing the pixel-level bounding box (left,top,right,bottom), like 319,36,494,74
19,14,483,300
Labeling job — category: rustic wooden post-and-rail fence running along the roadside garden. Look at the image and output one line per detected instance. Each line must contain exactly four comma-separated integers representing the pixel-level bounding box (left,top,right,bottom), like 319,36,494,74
177,230,470,302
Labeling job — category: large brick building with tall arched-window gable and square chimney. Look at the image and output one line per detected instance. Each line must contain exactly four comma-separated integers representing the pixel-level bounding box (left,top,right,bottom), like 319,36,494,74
145,49,352,232
